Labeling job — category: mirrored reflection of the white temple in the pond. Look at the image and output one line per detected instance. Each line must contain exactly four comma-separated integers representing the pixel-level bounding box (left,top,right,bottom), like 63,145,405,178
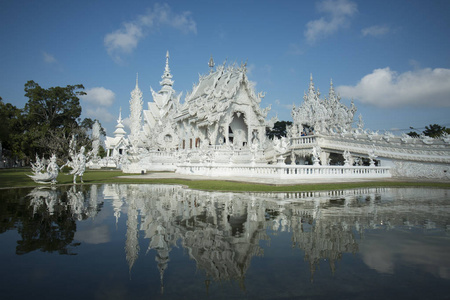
103,185,448,287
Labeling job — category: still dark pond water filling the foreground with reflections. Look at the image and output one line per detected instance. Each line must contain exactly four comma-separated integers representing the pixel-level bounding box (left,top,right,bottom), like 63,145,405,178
0,184,450,299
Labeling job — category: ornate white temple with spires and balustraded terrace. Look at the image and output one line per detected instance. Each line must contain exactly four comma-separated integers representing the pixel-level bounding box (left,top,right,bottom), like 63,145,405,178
104,52,450,179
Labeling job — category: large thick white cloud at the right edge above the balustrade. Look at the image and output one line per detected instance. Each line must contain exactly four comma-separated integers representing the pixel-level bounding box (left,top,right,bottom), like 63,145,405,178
336,67,450,107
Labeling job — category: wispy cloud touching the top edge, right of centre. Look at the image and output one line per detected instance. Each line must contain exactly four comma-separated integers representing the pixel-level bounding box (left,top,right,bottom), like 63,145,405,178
305,0,358,44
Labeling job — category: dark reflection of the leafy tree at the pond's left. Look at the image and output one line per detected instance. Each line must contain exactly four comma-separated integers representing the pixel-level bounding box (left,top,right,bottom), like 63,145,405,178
0,186,101,255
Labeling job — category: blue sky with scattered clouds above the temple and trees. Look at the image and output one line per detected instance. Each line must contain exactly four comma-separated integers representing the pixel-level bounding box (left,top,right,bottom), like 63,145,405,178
0,0,450,134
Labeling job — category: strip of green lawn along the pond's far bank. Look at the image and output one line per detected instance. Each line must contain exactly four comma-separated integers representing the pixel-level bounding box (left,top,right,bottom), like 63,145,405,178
0,168,450,192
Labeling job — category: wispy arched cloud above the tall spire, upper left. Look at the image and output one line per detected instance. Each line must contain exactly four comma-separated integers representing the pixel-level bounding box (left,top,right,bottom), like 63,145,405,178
104,4,197,62
